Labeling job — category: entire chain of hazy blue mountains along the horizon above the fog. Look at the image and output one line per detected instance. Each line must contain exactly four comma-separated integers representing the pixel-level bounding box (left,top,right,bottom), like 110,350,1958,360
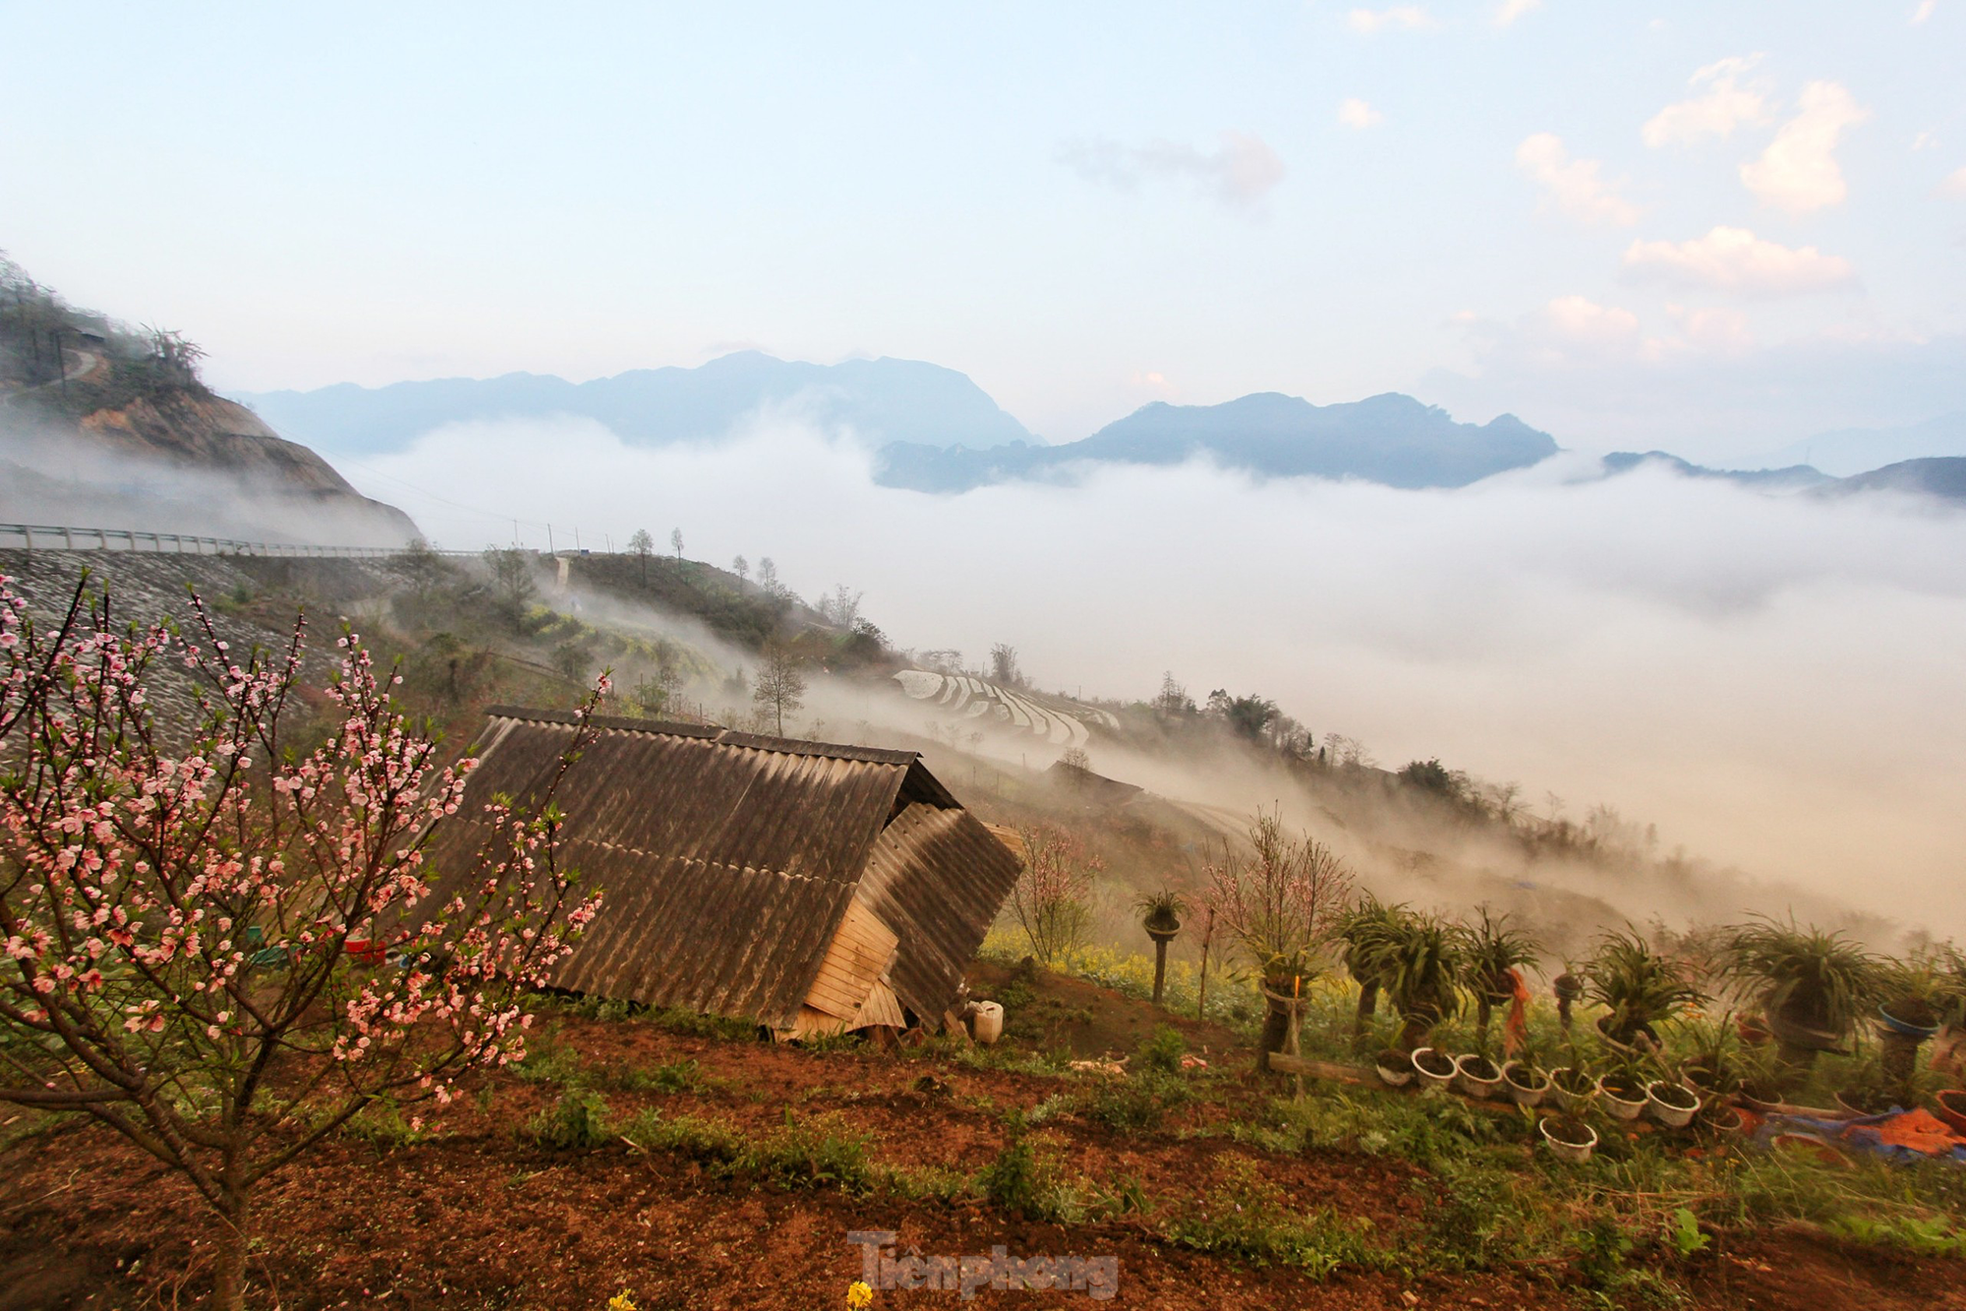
238,350,1966,497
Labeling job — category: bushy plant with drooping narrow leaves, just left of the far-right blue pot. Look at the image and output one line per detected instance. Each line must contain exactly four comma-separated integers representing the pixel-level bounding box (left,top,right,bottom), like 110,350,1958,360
1726,920,1883,1071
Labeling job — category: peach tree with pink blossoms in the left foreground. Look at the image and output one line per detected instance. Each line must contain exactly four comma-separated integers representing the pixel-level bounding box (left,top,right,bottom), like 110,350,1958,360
0,576,606,1307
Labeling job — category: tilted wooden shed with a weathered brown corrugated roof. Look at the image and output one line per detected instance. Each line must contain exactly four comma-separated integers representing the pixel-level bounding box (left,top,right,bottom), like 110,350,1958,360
433,706,1020,1036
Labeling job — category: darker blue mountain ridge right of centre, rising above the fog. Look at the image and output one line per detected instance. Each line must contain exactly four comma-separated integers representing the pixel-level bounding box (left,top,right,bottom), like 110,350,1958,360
877,391,1557,491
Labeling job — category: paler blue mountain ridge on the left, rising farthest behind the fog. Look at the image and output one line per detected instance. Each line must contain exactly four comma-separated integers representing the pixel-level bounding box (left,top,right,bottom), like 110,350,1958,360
234,350,1036,458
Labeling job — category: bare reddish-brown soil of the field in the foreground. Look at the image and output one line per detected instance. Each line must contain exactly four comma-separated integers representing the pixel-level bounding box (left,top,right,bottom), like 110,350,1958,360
0,981,1966,1311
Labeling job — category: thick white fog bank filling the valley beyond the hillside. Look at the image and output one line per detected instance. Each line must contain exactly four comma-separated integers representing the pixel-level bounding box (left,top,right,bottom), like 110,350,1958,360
344,421,1966,932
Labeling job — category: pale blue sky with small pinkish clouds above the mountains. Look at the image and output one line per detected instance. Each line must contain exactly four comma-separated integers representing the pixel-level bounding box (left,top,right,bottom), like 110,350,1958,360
0,0,1966,458
